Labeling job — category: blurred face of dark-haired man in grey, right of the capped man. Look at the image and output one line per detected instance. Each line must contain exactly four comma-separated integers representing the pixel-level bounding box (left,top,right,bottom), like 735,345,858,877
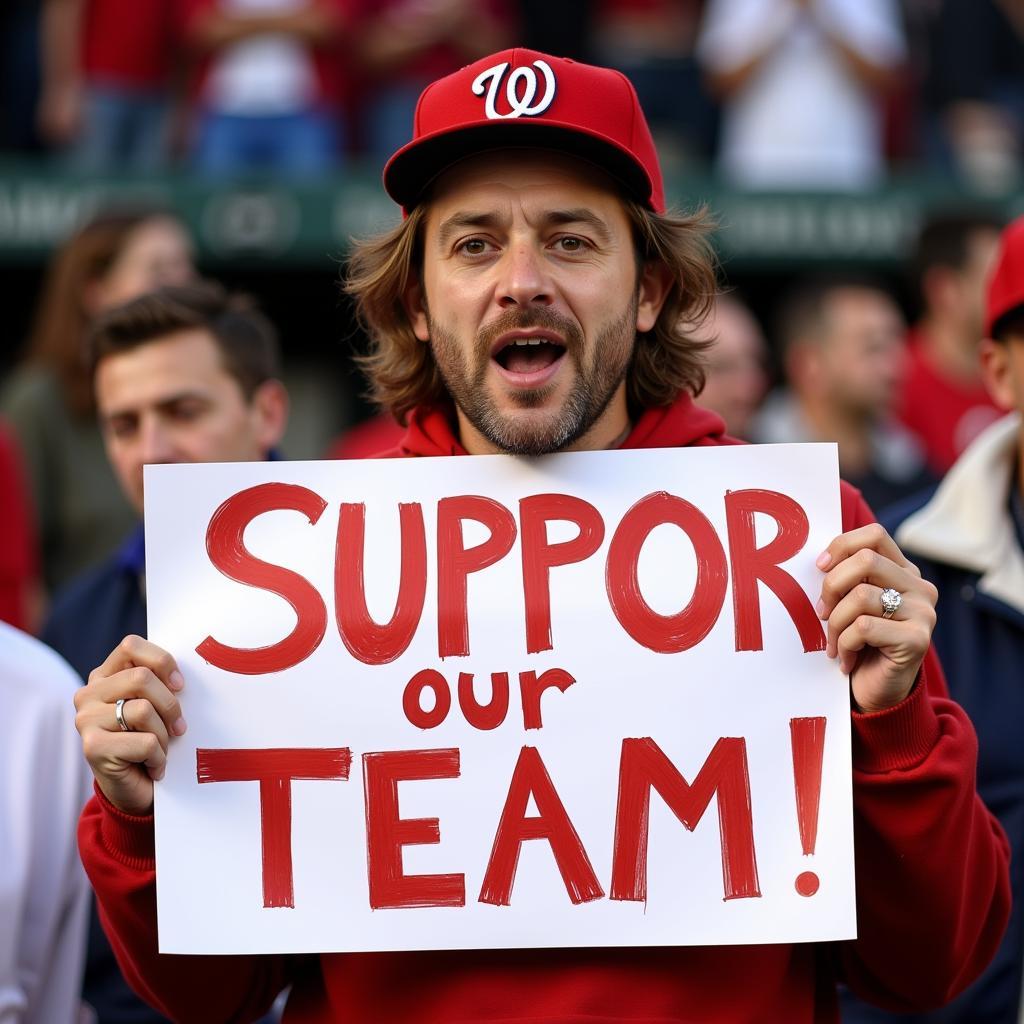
820,288,906,420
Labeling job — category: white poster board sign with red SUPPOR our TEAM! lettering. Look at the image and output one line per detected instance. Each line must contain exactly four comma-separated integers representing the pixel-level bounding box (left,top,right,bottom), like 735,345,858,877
145,445,855,953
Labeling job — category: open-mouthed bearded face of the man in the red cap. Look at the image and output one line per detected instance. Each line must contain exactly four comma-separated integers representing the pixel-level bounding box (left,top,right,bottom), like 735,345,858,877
407,151,665,455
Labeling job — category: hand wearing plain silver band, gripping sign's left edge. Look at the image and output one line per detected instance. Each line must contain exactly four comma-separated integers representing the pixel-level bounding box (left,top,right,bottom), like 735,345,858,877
75,636,185,815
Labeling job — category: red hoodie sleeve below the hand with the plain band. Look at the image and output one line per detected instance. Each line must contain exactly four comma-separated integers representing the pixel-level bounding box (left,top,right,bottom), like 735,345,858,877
78,790,293,1024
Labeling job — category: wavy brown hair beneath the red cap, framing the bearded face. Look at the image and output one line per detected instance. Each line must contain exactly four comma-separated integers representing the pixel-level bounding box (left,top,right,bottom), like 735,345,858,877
343,200,717,423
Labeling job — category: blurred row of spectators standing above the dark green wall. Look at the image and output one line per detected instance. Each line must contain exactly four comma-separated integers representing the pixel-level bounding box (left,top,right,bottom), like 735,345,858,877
0,0,1024,189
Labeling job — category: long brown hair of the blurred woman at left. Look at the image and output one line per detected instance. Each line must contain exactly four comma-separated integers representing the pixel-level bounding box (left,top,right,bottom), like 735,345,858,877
26,207,173,416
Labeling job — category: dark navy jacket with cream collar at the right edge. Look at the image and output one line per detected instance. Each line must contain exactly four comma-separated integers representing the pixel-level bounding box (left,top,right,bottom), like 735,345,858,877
843,417,1024,1024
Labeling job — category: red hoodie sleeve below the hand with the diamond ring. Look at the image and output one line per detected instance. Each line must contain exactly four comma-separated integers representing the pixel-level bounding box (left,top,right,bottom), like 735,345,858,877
837,479,1011,1011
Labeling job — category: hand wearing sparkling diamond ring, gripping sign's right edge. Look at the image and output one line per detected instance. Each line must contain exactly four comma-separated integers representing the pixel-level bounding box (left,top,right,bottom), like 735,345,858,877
816,523,938,711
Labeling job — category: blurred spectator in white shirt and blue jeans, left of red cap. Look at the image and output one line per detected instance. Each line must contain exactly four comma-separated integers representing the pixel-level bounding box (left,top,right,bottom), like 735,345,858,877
179,0,355,176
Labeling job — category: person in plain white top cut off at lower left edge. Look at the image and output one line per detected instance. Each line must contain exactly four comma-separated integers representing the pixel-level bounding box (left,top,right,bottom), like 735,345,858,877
0,623,91,1024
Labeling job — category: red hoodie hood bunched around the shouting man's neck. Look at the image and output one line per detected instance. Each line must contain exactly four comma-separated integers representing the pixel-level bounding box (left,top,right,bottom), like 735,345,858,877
385,393,741,458
